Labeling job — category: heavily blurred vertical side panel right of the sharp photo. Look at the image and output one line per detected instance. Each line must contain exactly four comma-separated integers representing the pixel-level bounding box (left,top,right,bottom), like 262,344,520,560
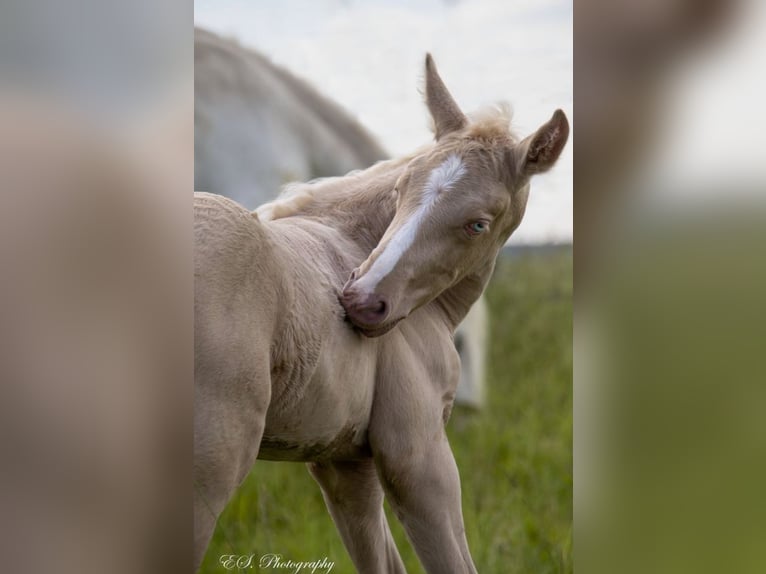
574,0,766,574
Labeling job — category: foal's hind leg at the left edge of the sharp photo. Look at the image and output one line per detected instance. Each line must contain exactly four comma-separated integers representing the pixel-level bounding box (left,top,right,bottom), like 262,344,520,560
193,366,271,572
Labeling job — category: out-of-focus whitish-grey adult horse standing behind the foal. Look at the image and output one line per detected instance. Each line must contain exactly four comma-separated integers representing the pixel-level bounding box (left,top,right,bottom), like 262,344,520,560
194,28,488,408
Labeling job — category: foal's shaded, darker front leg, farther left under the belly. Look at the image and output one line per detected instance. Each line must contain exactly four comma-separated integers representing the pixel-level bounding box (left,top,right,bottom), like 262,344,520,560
308,459,406,574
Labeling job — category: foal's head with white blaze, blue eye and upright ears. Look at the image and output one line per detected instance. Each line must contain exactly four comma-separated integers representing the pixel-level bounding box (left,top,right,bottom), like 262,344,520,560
341,55,569,336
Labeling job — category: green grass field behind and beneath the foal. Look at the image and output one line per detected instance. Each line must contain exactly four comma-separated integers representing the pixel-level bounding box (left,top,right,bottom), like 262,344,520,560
201,247,572,574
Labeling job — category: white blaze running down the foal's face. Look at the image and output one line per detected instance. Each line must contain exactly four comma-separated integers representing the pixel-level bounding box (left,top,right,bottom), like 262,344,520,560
364,155,465,290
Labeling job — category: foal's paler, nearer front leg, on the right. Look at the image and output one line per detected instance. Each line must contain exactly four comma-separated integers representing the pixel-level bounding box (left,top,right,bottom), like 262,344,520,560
370,381,476,574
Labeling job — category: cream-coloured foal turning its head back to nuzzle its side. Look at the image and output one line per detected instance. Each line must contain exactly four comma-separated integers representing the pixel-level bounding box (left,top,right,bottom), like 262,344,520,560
194,57,569,573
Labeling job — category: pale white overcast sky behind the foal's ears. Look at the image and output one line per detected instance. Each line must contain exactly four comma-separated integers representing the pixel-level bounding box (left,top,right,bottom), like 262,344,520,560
194,0,573,243
